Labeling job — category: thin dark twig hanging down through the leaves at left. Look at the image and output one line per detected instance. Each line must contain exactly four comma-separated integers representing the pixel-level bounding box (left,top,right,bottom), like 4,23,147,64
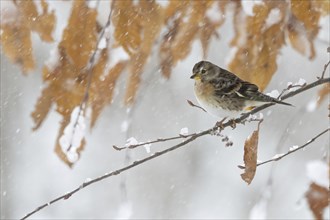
67,2,113,151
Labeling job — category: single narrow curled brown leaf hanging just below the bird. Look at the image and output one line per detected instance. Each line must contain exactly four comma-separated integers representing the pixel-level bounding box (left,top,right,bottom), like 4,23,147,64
241,121,262,184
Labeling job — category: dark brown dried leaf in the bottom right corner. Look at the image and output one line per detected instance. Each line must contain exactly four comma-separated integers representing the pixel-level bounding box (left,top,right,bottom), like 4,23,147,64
305,183,330,220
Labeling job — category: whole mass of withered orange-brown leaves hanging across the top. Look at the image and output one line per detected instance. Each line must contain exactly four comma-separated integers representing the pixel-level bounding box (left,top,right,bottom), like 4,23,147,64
1,0,330,166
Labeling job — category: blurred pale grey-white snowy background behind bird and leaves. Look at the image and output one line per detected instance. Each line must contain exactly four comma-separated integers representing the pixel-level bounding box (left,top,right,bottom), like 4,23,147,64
1,1,329,219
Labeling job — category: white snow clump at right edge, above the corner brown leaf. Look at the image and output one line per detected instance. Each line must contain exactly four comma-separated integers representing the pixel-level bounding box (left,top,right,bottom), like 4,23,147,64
306,160,329,188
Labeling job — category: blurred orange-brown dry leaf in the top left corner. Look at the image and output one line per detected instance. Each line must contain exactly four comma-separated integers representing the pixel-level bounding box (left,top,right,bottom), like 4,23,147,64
1,1,55,73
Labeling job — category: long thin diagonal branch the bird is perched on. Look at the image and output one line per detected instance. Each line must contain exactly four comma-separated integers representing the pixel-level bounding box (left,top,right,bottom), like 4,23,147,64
22,78,330,219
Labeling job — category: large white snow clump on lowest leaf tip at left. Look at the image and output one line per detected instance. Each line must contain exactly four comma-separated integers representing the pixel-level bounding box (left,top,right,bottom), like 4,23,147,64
59,106,86,163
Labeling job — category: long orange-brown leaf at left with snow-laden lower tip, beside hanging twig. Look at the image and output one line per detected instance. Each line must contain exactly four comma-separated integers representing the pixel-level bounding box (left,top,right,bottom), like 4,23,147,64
32,0,99,166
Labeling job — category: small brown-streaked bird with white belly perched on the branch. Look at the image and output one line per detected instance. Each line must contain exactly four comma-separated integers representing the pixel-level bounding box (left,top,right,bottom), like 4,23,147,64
190,61,291,118
